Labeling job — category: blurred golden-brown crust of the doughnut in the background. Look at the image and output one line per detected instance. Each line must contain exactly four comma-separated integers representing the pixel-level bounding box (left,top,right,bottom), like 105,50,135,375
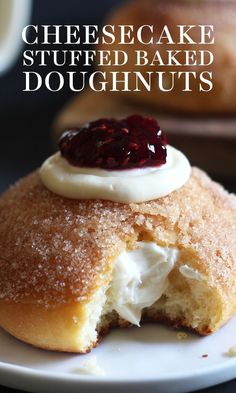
99,0,236,114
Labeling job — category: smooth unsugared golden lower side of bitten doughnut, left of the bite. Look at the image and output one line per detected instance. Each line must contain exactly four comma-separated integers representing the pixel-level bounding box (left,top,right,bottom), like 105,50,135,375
0,301,90,353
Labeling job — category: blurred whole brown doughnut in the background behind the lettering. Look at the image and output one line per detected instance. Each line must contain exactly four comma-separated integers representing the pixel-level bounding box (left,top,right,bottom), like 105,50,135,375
99,0,236,115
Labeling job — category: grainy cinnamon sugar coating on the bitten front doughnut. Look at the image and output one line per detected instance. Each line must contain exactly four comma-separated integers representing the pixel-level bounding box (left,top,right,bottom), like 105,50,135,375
0,168,236,307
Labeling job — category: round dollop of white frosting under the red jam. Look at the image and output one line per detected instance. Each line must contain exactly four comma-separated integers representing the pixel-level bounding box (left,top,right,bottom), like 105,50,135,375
39,145,191,203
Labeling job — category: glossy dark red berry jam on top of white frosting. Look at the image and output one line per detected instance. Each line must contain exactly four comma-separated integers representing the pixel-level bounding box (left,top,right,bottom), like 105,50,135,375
59,115,167,170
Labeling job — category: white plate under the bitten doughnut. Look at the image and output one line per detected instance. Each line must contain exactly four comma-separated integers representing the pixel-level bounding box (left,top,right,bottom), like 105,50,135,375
0,319,236,393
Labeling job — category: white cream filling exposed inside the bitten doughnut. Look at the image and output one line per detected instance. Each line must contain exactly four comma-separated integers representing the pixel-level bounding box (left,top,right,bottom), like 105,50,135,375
106,241,179,326
